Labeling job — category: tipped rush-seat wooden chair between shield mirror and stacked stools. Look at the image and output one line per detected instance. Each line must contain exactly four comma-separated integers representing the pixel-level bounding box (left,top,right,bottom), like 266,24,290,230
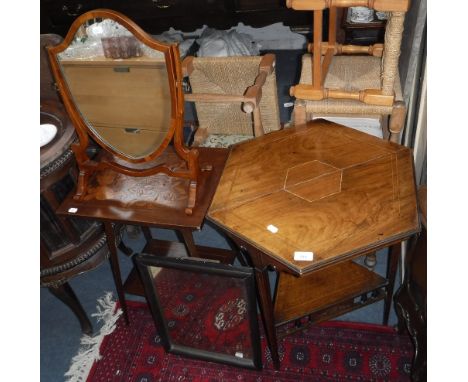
182,54,281,147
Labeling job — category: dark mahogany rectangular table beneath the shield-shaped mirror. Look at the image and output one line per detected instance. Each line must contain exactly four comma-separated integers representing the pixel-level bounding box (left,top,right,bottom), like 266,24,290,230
57,148,234,322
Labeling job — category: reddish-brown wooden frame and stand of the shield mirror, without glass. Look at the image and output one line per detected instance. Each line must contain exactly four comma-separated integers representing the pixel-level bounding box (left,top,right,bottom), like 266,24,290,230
47,9,205,215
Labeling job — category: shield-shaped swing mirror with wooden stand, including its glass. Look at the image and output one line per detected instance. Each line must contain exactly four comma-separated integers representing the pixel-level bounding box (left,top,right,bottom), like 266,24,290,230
48,9,205,214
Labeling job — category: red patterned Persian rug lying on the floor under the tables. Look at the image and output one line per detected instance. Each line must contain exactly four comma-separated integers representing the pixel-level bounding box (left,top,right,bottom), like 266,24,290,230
67,302,413,382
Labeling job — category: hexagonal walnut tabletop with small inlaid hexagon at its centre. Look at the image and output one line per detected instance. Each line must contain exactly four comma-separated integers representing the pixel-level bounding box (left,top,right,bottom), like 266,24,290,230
208,121,419,275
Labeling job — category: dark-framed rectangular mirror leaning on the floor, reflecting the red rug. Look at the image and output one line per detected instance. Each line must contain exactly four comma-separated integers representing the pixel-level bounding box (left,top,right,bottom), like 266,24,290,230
133,253,262,369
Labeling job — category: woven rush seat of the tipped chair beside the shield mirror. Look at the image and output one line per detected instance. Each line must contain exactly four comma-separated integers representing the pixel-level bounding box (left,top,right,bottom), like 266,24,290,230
184,56,281,147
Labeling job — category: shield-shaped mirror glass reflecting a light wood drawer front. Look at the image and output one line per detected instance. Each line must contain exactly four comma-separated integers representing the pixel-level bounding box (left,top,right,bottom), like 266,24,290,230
58,19,171,159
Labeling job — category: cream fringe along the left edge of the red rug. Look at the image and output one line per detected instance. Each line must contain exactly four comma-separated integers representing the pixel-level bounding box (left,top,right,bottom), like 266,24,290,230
64,292,122,382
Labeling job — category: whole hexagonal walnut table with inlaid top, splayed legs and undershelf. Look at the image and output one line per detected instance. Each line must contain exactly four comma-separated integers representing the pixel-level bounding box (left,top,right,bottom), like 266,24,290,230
208,121,420,367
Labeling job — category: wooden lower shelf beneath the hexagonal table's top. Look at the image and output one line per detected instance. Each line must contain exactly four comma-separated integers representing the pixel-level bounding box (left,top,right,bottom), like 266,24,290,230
274,261,388,326
